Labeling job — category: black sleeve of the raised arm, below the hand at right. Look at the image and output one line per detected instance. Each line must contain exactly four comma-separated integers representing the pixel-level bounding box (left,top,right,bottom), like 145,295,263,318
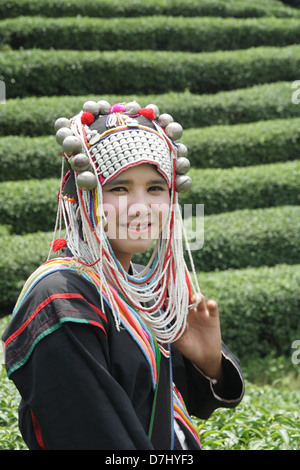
172,343,244,419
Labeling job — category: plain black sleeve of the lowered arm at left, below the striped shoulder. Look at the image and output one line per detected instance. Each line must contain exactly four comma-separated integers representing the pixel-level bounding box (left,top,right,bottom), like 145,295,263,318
11,323,152,450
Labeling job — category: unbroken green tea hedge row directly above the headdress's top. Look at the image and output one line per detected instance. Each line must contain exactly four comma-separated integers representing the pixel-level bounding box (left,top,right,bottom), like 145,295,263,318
0,44,300,98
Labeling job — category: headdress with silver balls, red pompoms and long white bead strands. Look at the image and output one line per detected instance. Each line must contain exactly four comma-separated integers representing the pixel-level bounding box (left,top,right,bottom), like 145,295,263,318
54,100,200,343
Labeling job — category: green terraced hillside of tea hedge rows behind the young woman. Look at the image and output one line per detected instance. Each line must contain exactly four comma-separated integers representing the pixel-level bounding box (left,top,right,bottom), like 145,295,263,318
0,0,300,364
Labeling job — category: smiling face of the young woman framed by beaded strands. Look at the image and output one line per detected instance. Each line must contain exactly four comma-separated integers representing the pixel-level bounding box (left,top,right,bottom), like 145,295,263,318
102,163,170,270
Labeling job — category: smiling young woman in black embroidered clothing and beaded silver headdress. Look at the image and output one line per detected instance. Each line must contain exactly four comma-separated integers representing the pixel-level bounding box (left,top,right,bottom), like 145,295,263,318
3,100,244,450
